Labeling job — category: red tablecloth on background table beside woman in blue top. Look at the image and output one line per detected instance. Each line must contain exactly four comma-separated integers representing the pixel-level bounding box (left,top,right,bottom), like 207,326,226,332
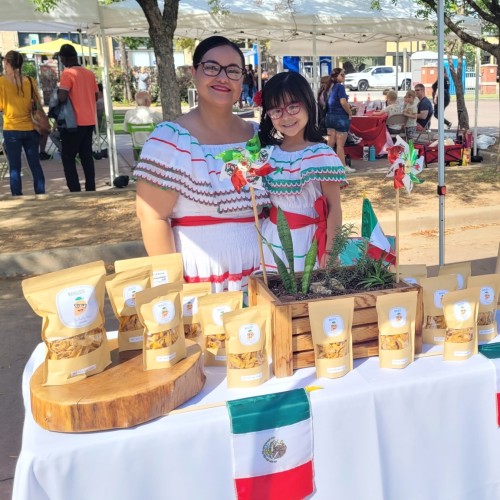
344,115,390,158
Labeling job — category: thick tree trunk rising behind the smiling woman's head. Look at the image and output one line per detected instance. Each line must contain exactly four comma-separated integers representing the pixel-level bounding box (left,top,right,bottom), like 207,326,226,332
136,0,181,120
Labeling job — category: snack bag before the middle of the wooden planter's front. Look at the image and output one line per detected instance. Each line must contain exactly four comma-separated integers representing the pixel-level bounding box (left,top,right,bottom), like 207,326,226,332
309,297,354,378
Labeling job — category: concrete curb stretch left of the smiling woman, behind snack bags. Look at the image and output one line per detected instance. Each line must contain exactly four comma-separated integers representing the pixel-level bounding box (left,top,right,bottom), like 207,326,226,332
0,241,146,278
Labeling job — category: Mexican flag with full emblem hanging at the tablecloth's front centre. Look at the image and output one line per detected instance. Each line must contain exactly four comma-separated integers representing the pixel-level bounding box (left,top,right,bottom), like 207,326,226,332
226,389,314,500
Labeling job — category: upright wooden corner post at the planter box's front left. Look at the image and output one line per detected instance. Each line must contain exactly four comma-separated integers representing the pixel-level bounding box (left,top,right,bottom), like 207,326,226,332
271,303,293,377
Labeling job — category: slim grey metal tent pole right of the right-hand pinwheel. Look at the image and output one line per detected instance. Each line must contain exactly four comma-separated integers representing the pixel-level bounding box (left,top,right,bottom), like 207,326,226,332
437,0,445,266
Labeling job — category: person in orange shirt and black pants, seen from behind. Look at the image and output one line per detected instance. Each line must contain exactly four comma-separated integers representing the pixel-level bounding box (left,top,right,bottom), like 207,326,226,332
58,44,99,191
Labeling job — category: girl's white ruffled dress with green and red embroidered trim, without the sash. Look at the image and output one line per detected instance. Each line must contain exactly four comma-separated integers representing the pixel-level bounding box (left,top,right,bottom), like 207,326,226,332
262,143,347,272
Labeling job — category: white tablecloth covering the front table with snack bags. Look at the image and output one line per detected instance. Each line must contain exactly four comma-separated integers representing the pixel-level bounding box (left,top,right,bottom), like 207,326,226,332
13,336,500,500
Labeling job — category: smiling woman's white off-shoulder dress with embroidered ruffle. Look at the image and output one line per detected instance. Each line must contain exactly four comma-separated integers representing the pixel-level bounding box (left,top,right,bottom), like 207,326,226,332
134,122,269,292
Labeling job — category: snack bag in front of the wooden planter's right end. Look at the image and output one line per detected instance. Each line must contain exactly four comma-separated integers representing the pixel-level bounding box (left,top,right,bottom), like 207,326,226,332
376,291,418,368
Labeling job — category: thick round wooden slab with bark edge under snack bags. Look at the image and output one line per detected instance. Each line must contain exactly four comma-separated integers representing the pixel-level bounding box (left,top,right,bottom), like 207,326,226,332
30,340,206,432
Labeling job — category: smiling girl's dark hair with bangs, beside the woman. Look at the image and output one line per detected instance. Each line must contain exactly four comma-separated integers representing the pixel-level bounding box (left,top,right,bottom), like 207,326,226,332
259,71,325,146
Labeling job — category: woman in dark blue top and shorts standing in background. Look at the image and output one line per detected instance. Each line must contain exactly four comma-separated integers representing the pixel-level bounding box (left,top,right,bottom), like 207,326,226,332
326,68,356,173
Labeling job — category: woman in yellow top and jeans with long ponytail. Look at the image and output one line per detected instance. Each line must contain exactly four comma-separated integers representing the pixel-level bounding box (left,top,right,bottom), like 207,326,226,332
0,50,45,196
